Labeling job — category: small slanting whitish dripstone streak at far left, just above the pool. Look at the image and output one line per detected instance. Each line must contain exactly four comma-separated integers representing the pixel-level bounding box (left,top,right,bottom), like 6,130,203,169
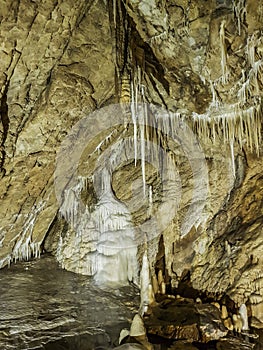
10,201,45,262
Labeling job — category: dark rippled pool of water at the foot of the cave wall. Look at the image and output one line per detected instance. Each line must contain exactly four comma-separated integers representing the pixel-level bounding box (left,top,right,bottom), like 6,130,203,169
0,256,139,350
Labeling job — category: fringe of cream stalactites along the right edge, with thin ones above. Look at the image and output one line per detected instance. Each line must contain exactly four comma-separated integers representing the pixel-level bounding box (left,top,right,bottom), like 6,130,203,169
196,24,263,155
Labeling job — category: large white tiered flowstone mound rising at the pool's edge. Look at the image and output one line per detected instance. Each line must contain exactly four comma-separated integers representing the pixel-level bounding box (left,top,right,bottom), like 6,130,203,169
57,163,137,285
